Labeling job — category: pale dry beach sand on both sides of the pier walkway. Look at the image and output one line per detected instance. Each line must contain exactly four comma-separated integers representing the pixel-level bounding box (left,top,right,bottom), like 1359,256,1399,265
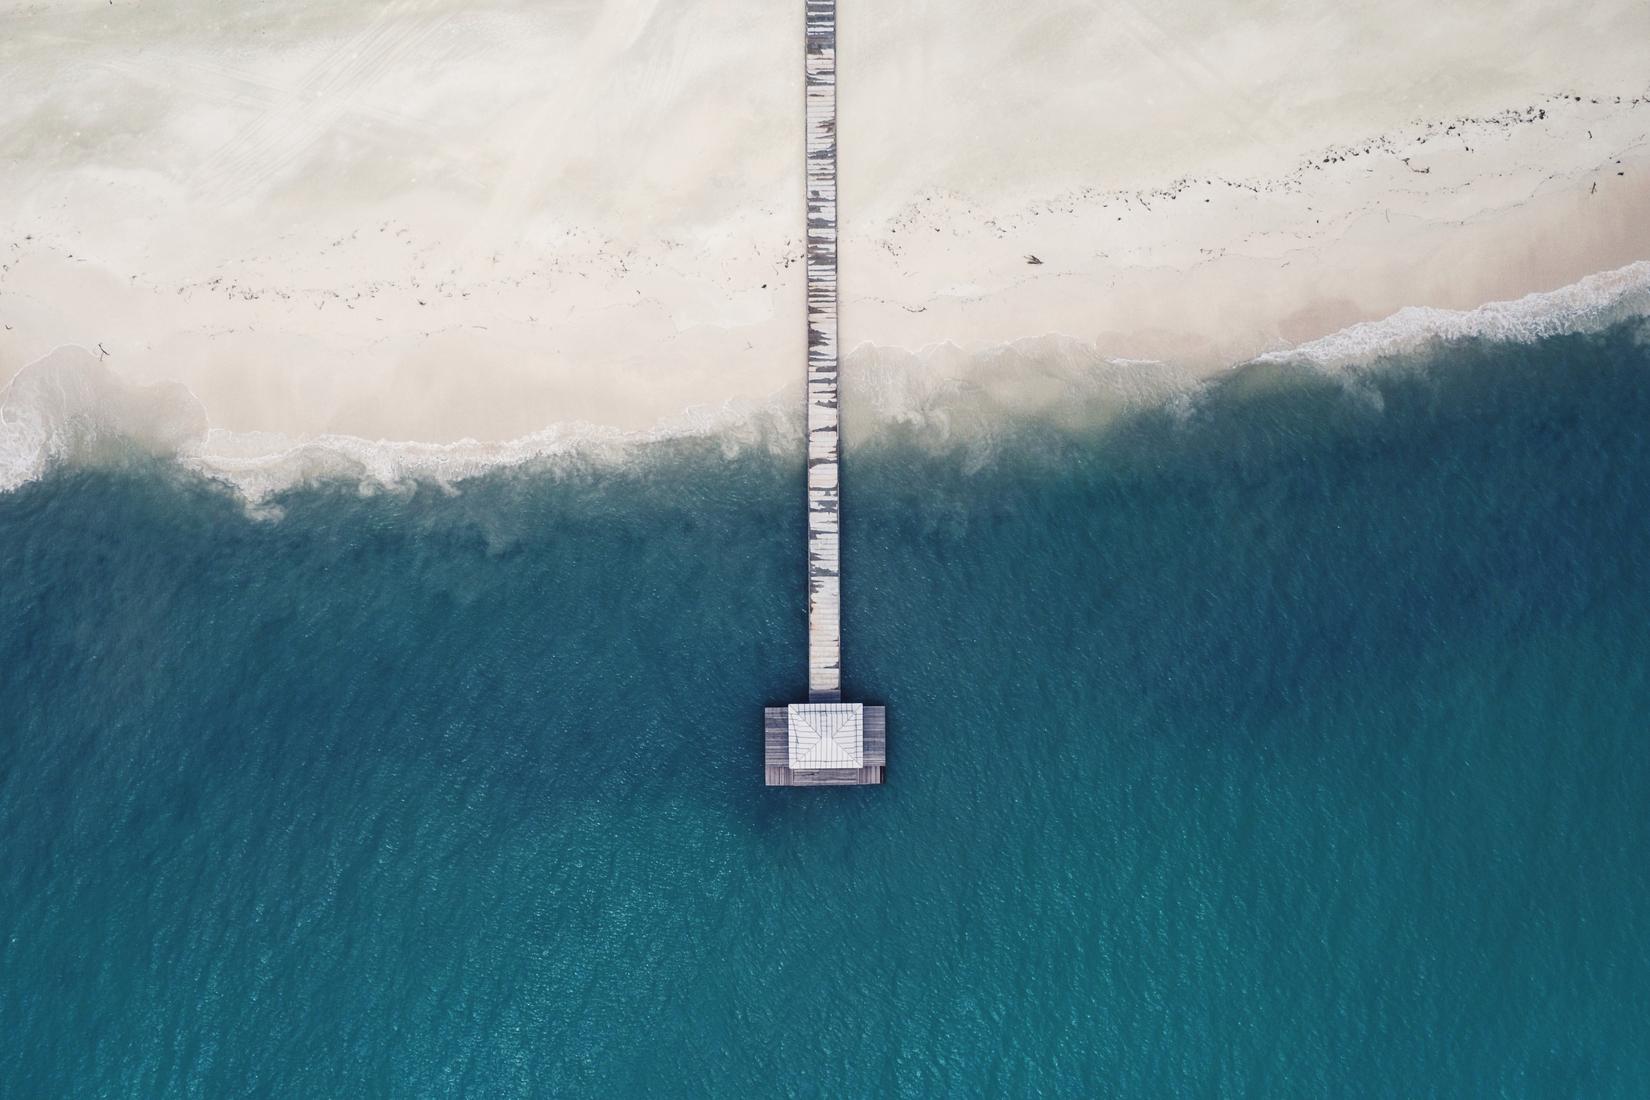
0,0,1650,481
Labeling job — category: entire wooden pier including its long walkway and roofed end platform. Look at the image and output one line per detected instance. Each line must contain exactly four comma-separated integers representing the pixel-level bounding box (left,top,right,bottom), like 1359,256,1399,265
762,0,888,787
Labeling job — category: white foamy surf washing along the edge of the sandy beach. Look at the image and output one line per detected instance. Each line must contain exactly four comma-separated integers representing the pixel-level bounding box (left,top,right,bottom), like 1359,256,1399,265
0,262,1650,508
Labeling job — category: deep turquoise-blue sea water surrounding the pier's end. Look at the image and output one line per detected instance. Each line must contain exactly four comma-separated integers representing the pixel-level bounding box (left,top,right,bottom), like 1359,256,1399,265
0,327,1650,1097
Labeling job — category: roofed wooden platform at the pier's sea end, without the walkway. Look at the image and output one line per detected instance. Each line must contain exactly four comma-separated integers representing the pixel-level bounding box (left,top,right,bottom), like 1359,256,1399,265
762,703,888,787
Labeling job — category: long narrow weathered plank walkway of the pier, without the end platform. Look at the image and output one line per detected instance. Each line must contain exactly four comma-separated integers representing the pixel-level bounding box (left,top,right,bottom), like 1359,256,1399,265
805,0,842,703
